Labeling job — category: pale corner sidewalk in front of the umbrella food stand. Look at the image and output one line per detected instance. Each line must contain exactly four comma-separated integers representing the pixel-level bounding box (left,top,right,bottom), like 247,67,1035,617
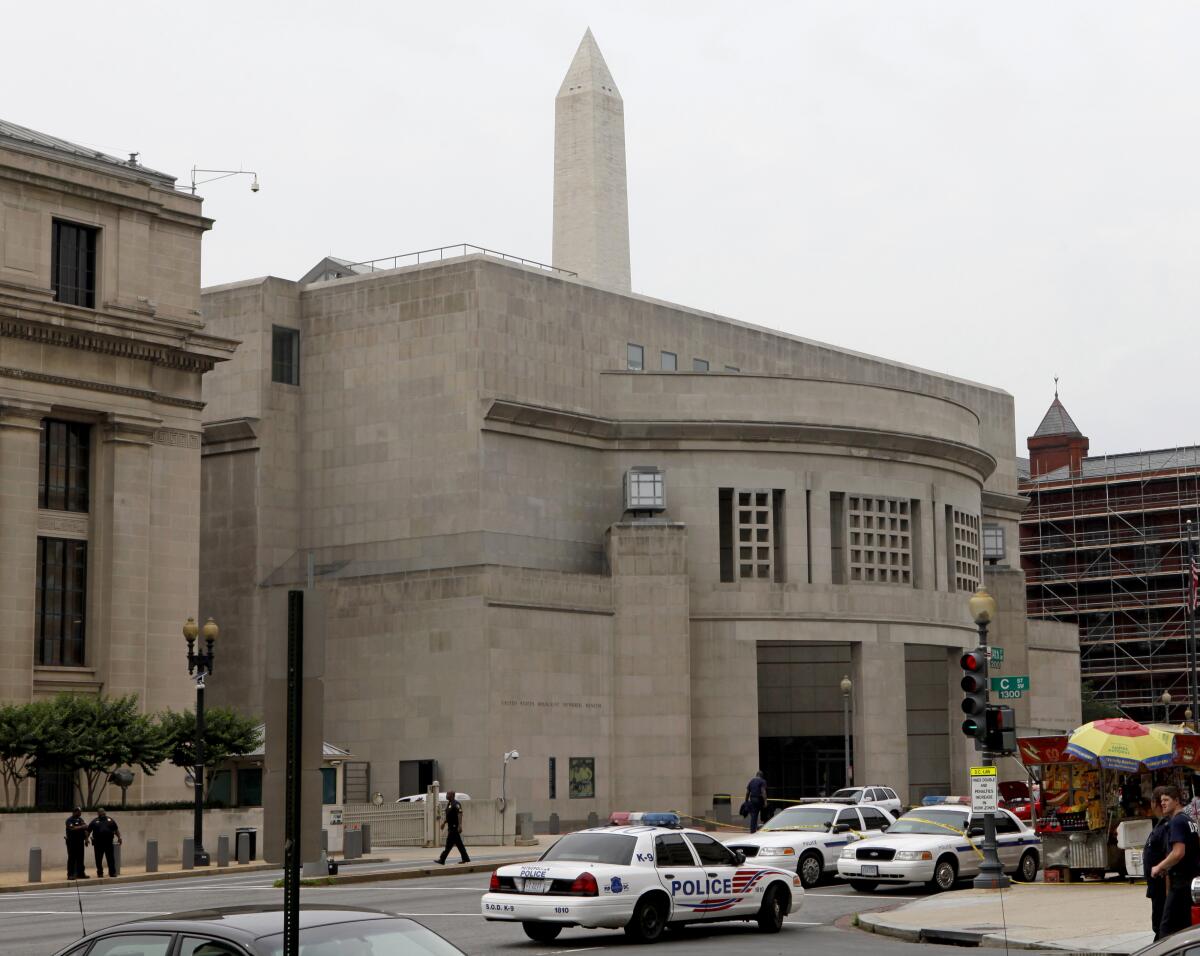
858,883,1154,954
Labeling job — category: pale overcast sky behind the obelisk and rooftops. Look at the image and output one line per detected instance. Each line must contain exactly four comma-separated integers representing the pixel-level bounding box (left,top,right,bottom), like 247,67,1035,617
11,0,1200,453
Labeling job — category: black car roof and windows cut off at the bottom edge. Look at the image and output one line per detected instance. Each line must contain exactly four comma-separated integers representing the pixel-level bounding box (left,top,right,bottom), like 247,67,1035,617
56,906,463,956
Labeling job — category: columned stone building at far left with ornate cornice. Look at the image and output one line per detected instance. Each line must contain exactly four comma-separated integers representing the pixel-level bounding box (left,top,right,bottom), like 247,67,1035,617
0,121,236,805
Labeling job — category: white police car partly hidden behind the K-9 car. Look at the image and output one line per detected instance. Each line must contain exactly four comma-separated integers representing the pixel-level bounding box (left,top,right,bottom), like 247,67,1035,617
726,802,895,890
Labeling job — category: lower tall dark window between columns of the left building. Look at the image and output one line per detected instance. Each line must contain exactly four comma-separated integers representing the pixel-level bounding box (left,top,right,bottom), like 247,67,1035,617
34,537,88,667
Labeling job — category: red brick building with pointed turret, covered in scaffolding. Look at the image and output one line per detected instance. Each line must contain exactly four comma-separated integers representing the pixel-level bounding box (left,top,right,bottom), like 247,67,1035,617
1019,393,1200,721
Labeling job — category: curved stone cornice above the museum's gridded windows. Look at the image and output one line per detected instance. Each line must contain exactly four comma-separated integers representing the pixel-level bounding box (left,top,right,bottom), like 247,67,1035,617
484,398,996,481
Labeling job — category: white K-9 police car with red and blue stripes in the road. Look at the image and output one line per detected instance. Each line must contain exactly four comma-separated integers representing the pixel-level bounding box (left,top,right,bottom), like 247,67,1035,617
480,826,804,943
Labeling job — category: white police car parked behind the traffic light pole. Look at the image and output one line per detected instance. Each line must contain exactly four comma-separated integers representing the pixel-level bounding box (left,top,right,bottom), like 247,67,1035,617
838,804,1042,891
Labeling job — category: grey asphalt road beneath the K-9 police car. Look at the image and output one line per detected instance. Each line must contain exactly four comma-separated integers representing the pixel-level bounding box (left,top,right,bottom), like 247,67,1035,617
0,867,1063,956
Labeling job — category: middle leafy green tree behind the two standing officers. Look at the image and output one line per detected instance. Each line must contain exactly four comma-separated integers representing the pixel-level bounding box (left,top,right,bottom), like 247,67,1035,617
34,693,168,806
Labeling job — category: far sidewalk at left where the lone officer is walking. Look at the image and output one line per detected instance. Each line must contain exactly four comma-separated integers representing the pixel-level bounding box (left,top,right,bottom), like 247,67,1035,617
0,835,549,894
